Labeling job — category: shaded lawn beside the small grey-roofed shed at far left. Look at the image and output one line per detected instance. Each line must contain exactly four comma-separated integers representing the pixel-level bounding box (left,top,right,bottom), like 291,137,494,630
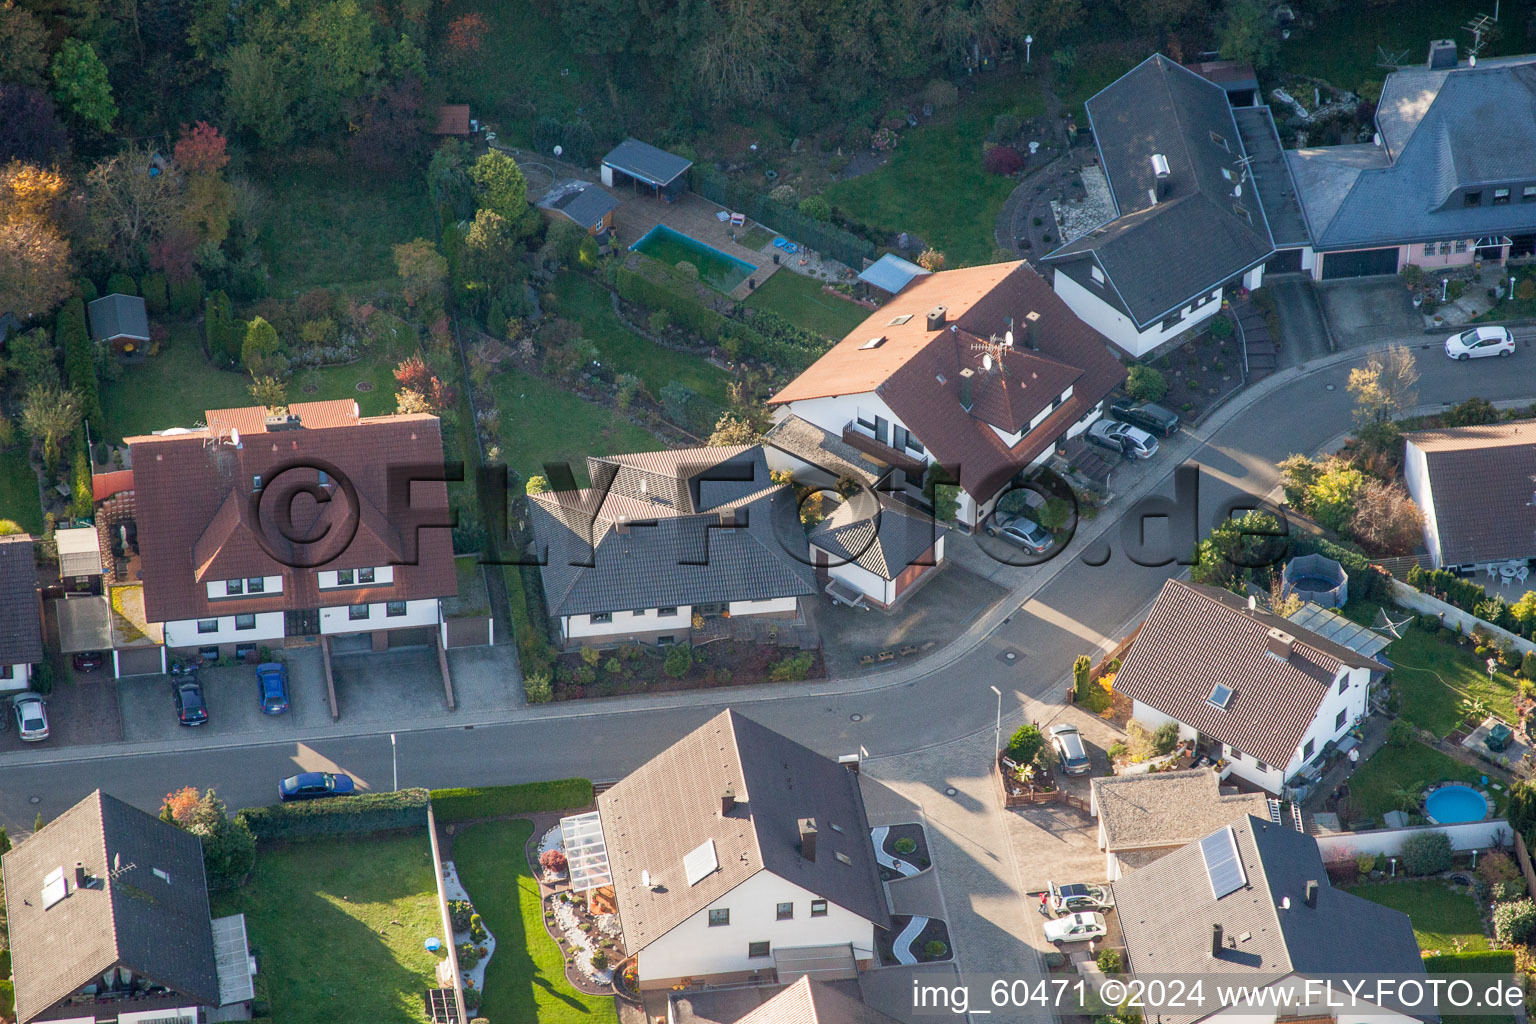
101,321,248,441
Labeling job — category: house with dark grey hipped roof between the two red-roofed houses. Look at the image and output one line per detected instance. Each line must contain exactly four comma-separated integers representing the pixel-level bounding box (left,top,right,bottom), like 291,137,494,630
528,445,816,645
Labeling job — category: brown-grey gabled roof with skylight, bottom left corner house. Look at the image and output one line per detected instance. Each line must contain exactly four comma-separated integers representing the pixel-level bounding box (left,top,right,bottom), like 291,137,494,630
3,789,218,1024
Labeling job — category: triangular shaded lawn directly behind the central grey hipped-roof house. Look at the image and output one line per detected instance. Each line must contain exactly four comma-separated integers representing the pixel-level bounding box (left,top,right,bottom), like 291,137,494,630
492,367,667,484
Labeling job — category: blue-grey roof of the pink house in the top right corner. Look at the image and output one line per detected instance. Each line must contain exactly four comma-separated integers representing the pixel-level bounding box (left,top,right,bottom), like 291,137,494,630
1292,57,1536,249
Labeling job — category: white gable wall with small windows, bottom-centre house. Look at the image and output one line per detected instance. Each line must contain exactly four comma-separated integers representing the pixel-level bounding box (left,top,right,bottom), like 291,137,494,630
637,872,874,984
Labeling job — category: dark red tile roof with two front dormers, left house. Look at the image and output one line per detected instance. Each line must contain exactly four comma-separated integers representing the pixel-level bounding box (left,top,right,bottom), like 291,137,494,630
127,401,458,622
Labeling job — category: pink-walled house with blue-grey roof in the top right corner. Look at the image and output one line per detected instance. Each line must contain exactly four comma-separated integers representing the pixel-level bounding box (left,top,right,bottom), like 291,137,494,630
1286,40,1536,279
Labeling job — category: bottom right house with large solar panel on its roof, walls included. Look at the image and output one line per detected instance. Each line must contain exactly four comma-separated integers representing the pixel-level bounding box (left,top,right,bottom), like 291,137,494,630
1112,815,1424,1024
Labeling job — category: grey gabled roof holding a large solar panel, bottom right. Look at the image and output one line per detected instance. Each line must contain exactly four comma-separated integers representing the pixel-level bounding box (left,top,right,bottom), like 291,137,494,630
1112,815,1424,1021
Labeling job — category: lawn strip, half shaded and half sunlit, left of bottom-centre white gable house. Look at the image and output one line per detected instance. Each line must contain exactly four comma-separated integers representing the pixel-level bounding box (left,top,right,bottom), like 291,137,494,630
453,818,617,1024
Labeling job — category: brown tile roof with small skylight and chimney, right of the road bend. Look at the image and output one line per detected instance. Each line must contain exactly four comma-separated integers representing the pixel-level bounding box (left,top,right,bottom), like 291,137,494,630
1115,580,1385,768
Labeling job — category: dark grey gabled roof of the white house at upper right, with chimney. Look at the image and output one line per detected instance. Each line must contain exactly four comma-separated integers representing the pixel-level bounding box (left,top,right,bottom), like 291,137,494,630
1046,54,1275,327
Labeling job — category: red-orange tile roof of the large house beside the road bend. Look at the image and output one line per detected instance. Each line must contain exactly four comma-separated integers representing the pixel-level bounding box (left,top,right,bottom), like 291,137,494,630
773,263,1126,499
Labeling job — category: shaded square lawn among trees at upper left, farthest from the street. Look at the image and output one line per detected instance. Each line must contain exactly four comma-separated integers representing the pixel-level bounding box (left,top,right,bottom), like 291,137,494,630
258,161,435,298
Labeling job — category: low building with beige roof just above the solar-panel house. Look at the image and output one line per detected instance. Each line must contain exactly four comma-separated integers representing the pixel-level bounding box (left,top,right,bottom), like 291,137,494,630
1089,768,1278,881
